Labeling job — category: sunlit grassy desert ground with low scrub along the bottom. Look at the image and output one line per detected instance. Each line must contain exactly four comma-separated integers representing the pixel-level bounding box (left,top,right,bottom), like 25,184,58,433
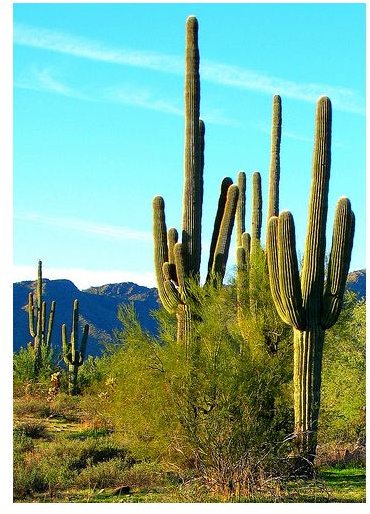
14,399,365,503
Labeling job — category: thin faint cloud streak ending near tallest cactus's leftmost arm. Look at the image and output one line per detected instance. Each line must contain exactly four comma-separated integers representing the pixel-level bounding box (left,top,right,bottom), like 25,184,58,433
14,212,152,242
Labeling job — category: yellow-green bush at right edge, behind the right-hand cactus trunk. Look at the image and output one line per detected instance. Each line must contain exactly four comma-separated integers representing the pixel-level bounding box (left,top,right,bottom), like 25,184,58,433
319,293,366,447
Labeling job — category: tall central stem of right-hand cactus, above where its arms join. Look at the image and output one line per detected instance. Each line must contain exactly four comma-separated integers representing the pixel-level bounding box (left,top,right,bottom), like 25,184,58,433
302,97,331,324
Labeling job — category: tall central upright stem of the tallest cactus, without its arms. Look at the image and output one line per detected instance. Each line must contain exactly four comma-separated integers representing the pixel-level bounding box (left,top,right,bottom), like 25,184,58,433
182,16,203,277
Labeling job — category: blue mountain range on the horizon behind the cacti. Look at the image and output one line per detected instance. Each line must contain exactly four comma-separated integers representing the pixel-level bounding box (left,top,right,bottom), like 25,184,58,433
13,270,366,355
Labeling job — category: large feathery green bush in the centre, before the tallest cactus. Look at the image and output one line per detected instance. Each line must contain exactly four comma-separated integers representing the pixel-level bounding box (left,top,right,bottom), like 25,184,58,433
92,278,292,489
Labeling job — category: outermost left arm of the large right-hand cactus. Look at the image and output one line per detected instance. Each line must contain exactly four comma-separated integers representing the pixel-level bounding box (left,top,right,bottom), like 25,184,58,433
266,216,290,325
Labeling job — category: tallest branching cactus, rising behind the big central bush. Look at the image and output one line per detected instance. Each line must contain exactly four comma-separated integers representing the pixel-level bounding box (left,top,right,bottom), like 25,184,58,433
153,16,238,345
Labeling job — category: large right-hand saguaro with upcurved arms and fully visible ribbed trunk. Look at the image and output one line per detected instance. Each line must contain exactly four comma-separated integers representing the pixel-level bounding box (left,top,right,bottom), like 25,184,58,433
267,97,355,464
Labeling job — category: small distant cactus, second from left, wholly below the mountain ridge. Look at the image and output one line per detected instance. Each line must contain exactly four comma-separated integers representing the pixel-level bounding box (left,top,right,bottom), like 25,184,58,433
62,300,89,395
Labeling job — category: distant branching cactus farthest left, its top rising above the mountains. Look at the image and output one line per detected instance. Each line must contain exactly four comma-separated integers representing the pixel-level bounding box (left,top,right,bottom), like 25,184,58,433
28,261,56,375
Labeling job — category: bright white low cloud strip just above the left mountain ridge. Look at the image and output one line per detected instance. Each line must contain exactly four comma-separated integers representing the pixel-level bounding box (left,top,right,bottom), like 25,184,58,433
13,266,156,289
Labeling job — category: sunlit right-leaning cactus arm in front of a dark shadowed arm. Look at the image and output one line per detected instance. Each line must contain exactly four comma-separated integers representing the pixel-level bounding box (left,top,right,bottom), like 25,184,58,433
212,185,239,283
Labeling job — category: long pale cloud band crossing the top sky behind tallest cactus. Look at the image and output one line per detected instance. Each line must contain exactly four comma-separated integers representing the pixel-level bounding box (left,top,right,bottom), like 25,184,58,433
14,24,365,114
